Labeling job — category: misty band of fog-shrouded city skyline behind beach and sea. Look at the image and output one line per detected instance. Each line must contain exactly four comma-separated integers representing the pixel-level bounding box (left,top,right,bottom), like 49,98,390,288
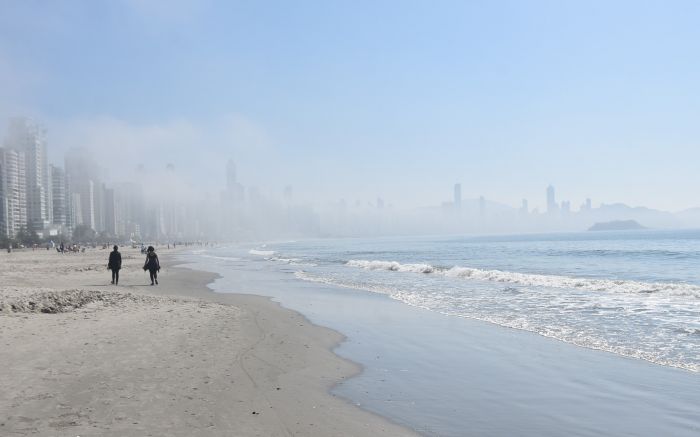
0,112,700,242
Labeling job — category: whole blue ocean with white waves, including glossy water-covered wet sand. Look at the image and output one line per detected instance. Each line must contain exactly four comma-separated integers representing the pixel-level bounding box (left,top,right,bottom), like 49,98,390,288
183,230,700,435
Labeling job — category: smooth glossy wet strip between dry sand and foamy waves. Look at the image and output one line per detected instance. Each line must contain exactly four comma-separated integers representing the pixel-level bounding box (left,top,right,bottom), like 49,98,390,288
191,250,700,436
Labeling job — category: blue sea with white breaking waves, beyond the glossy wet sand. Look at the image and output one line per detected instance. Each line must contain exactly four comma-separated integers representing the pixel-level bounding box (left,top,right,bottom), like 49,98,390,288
258,231,700,372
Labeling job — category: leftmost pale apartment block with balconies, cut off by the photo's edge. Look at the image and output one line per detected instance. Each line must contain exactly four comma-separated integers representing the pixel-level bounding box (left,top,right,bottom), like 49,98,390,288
0,147,27,238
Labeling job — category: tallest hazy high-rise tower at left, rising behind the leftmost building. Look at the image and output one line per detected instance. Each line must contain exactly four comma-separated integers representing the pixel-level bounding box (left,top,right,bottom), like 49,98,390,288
5,117,53,231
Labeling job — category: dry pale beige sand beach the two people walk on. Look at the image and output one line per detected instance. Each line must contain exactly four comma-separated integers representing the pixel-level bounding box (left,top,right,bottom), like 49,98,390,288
0,249,413,436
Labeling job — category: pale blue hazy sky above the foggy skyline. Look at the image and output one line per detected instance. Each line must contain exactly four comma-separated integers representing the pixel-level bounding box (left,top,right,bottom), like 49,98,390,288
0,0,700,211
